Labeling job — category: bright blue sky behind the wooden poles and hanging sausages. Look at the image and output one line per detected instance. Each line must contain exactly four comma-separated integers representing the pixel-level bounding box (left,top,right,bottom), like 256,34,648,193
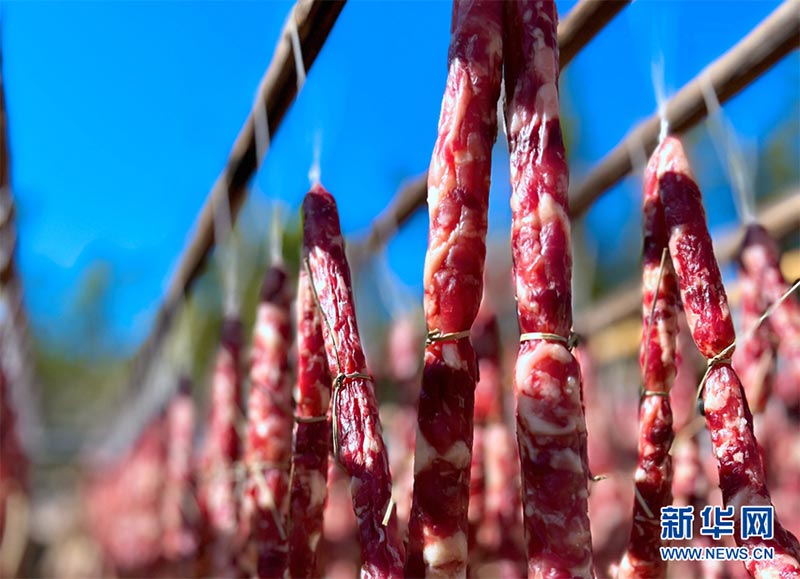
2,0,800,348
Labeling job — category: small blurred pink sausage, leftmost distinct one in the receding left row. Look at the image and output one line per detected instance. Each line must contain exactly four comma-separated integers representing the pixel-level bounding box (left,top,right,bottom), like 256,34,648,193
161,376,197,562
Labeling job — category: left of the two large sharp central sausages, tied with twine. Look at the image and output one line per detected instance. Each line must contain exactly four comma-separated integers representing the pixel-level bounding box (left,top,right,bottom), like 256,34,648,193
406,0,503,577
